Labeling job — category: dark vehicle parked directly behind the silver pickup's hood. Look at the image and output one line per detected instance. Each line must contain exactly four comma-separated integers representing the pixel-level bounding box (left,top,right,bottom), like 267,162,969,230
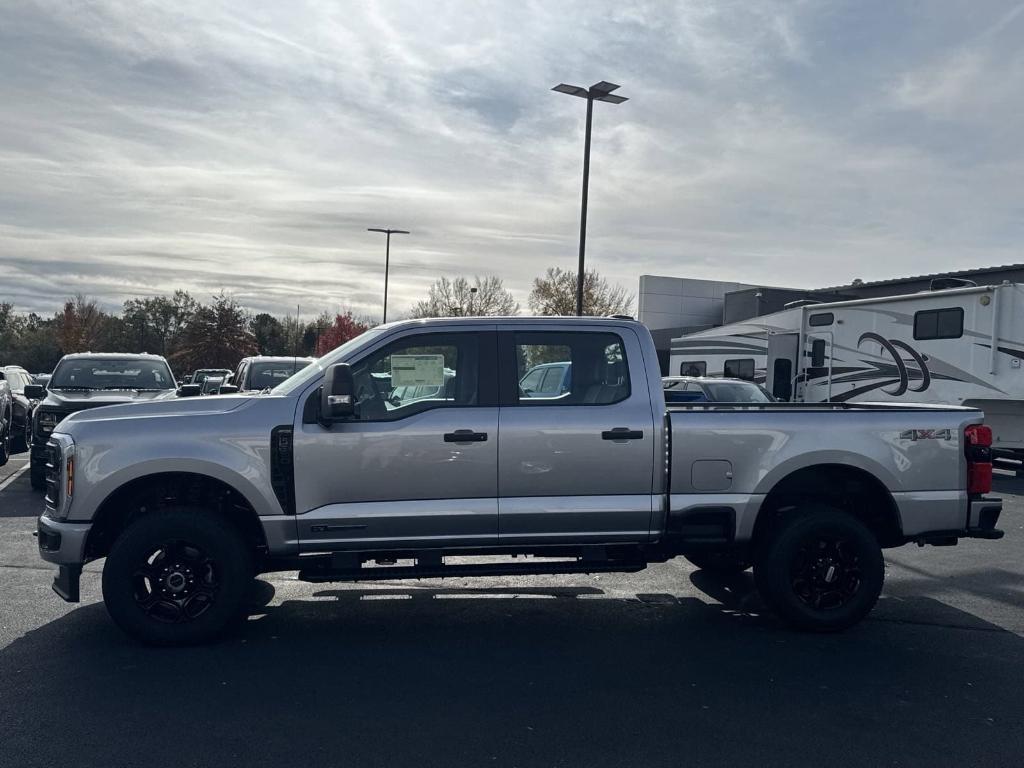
25,352,177,490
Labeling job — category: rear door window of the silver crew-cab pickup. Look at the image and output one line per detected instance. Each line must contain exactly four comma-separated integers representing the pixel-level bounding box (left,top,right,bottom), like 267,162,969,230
514,331,630,406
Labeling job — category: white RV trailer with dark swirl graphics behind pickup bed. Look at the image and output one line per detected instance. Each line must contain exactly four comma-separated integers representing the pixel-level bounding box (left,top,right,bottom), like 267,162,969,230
670,283,1024,458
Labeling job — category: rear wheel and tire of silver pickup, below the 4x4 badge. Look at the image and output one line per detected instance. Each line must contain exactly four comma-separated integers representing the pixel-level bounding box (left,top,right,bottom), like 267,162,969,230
754,504,885,632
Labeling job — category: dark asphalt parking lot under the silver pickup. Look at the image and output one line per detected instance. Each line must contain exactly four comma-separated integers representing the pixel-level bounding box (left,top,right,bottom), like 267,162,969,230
0,457,1024,768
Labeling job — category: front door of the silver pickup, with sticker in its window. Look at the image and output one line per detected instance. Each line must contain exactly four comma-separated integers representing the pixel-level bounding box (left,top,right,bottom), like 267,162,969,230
294,326,498,552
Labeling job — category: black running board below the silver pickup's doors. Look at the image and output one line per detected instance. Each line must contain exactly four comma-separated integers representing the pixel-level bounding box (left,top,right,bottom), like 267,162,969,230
299,558,647,584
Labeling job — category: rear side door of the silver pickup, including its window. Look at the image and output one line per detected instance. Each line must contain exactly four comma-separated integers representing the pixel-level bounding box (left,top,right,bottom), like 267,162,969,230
498,324,655,544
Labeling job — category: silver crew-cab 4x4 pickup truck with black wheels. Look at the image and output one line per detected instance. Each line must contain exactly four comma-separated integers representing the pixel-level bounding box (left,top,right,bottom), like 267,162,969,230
38,317,1001,645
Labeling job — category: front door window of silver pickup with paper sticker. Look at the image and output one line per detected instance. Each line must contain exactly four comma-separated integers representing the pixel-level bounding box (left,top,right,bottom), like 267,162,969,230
352,333,480,421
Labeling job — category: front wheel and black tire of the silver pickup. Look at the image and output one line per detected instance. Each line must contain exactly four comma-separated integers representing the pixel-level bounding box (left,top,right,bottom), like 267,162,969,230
102,507,253,646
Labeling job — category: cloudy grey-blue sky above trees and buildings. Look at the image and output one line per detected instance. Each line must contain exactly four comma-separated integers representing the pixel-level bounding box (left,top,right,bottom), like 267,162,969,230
0,0,1024,314
